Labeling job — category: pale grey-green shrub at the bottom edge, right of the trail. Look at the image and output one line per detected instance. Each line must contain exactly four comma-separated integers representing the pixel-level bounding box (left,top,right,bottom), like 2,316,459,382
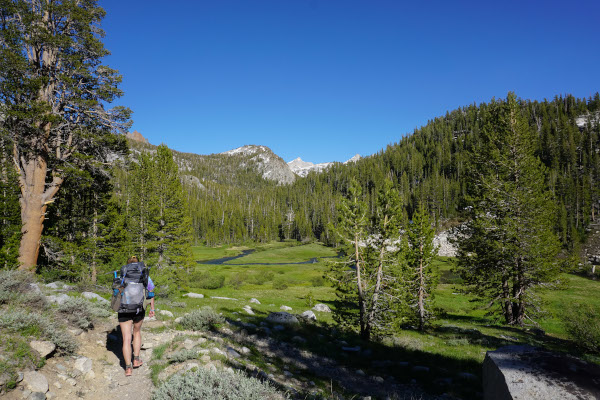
152,370,288,400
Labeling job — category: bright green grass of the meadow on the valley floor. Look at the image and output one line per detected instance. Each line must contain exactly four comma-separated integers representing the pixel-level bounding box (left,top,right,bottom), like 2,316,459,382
164,242,600,398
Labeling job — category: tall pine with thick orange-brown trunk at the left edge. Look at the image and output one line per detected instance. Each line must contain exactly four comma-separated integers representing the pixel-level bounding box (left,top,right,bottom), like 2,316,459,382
0,0,130,271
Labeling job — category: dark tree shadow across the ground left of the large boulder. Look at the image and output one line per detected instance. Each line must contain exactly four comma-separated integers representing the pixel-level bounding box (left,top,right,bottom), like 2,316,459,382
218,309,482,399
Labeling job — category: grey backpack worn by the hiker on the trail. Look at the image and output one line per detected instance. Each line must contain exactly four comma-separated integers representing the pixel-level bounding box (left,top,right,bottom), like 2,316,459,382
119,262,148,314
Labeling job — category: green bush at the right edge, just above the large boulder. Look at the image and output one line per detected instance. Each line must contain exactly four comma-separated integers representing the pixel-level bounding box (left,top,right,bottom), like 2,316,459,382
562,304,600,353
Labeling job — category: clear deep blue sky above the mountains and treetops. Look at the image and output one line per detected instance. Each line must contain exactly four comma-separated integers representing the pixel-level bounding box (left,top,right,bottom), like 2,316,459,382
99,0,600,162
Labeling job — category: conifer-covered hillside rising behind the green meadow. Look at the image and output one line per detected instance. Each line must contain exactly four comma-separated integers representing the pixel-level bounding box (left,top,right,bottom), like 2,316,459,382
173,94,600,247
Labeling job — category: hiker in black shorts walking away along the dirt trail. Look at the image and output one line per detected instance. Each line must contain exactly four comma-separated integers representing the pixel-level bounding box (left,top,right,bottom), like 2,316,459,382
118,256,154,376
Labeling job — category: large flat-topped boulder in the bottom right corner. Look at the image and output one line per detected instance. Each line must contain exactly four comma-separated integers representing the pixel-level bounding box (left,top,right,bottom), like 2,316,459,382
483,345,600,400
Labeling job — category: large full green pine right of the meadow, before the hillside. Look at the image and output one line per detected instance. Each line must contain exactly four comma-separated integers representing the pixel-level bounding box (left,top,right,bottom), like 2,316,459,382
458,93,560,325
